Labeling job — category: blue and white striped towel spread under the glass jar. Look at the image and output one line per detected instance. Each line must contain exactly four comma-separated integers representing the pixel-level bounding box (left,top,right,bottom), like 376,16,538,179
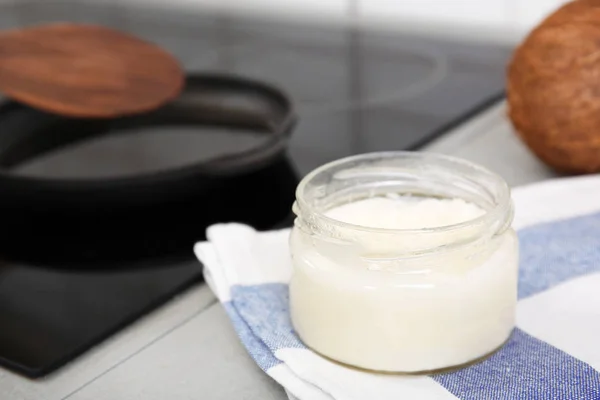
195,176,600,400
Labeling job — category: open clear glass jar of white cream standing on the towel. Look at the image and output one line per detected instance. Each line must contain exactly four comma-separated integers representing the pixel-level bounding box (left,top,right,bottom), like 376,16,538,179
290,152,518,373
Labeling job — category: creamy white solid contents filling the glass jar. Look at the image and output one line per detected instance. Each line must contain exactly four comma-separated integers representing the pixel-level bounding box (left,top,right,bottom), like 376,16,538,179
290,197,518,372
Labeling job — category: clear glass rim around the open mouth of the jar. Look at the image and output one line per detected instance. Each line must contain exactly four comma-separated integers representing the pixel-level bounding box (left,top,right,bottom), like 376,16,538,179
295,151,512,234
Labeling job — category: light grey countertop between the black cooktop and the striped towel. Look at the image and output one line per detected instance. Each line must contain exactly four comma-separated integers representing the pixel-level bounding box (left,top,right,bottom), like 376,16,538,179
0,103,554,400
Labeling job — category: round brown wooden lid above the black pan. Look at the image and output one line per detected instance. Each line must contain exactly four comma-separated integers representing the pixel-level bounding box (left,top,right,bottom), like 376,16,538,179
0,23,184,118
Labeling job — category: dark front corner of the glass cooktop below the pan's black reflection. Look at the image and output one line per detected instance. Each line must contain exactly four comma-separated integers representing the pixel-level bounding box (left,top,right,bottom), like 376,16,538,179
0,257,201,376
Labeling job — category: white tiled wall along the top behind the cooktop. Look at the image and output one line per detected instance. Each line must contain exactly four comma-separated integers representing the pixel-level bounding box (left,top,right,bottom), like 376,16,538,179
124,0,567,41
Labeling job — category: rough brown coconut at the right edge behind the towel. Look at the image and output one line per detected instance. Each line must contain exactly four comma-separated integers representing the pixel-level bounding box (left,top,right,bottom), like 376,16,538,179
507,0,600,173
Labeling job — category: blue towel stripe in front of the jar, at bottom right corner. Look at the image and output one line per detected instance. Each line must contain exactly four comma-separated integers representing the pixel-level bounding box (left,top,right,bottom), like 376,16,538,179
432,329,600,400
